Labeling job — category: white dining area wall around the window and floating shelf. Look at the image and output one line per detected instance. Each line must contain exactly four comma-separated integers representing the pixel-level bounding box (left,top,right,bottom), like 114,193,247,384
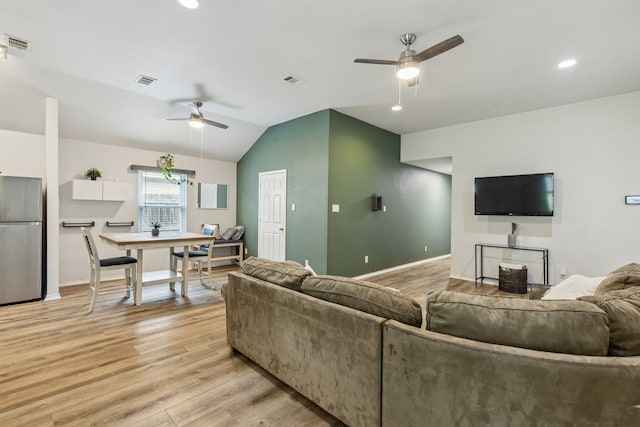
59,139,237,285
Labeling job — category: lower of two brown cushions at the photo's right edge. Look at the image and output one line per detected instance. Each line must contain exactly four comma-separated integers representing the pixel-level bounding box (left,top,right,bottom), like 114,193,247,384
580,286,640,356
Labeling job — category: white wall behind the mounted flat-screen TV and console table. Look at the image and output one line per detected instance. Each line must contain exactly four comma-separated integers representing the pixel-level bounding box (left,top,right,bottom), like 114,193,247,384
401,92,640,283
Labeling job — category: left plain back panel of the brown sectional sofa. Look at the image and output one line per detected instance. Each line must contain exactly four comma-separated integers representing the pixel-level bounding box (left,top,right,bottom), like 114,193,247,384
224,272,386,426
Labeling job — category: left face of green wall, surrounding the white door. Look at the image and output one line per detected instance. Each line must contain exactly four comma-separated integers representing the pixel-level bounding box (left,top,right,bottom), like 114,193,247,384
237,110,329,274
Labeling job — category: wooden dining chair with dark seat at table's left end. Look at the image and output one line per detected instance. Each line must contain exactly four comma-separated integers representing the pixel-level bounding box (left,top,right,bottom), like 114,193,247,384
80,227,138,313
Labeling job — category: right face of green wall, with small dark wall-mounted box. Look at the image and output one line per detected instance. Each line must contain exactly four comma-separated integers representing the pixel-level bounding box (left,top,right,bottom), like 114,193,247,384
327,111,451,276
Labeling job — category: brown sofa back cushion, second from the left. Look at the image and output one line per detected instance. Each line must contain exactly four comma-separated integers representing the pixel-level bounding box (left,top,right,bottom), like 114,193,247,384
302,275,422,327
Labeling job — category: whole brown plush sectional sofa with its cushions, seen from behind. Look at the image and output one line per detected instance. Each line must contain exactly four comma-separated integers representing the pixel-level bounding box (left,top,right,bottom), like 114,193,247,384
223,258,640,426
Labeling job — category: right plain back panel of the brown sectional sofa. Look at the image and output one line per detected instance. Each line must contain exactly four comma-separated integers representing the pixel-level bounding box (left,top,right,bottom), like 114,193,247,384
382,321,640,426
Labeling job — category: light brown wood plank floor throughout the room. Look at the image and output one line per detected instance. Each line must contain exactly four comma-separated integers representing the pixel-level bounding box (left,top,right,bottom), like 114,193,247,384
0,259,528,426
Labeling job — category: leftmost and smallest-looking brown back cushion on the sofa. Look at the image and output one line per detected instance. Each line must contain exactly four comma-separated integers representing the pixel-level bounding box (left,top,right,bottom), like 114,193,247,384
242,257,311,291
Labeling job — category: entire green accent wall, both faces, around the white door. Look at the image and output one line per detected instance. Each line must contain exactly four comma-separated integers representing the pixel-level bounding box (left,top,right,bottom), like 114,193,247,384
237,110,451,276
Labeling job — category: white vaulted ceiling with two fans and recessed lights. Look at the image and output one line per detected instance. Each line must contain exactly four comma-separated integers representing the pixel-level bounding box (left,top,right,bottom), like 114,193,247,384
0,0,640,161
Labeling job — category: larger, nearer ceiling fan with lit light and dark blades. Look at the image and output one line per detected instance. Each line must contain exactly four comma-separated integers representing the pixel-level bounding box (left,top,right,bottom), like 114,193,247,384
354,33,464,86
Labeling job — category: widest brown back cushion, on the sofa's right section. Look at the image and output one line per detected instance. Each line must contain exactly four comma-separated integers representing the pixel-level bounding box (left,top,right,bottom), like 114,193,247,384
427,291,609,356
